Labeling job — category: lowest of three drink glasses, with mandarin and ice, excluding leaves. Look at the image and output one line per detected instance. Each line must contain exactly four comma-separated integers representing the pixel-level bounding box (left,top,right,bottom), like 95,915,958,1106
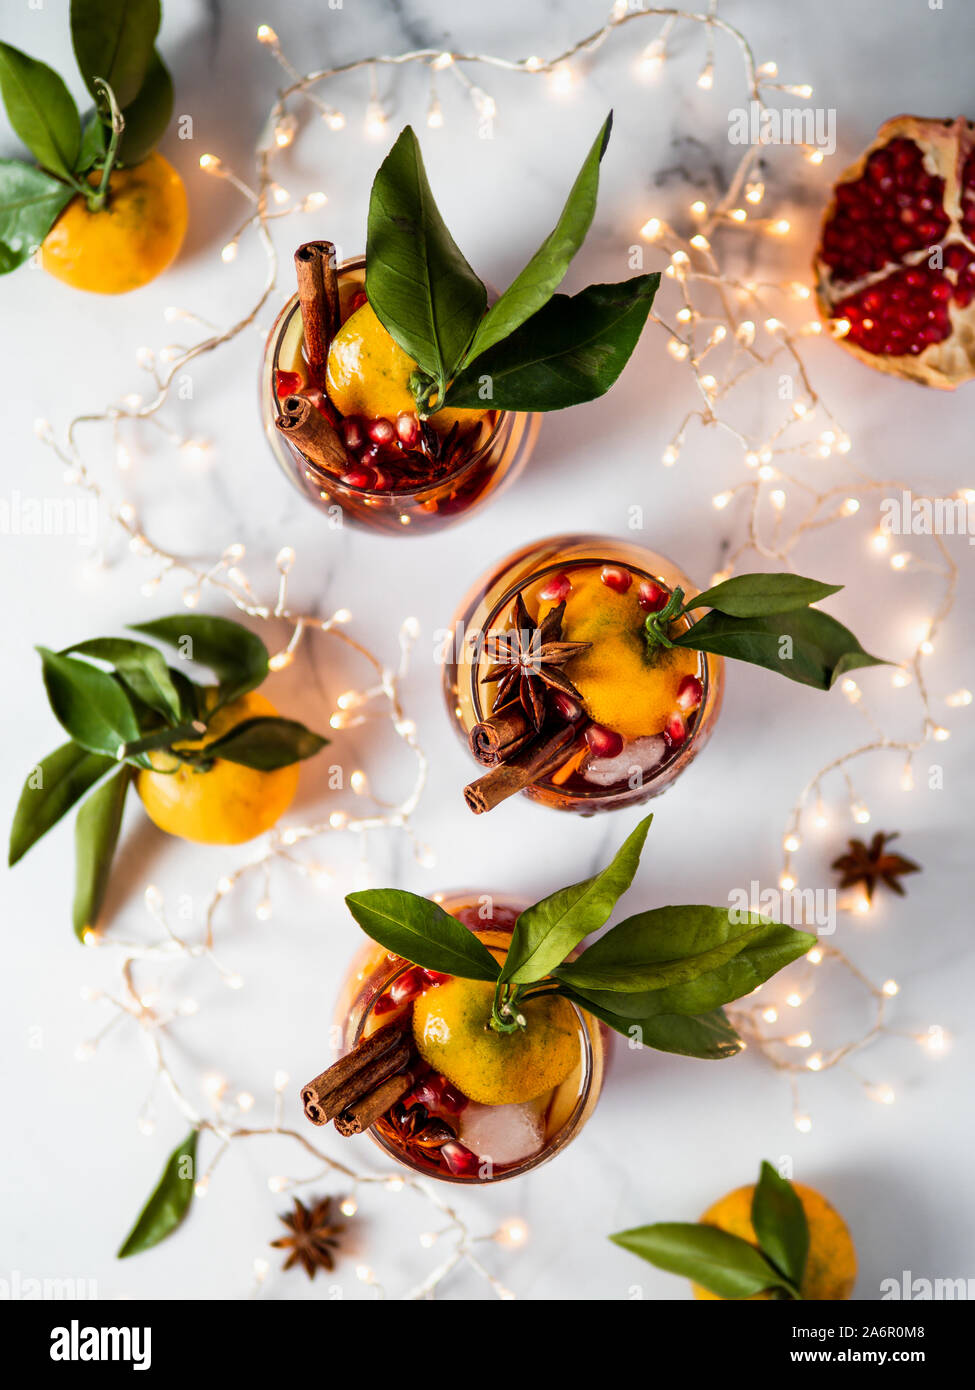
322,894,608,1183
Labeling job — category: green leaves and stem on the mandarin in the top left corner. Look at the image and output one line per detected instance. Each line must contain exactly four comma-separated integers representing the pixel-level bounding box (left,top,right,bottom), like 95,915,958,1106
0,0,172,274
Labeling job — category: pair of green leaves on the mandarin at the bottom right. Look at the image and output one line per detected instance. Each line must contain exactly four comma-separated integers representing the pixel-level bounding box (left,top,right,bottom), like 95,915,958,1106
609,1162,809,1300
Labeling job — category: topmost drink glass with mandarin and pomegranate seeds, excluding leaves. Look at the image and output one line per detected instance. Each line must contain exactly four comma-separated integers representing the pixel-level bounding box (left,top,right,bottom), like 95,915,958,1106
260,255,541,535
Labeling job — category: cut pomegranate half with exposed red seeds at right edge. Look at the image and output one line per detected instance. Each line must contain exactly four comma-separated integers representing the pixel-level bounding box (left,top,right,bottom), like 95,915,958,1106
815,115,975,391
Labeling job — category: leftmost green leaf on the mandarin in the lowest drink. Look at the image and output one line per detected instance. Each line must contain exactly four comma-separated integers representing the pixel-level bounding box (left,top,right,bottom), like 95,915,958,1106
345,888,501,980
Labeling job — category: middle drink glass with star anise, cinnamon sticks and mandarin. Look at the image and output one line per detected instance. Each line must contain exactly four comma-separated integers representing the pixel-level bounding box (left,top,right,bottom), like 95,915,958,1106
444,535,723,815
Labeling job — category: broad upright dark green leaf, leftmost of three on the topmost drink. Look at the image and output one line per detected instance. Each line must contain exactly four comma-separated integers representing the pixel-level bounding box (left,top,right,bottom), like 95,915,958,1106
366,125,487,396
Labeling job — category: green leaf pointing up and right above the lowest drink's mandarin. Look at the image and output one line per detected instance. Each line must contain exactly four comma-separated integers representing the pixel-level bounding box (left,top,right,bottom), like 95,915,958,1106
501,816,654,984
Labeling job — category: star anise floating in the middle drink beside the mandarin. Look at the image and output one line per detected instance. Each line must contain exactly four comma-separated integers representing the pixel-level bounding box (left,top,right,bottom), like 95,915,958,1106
481,594,591,728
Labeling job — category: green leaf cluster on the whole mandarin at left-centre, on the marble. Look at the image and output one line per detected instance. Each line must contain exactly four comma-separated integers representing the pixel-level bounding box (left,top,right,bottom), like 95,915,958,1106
8,614,328,937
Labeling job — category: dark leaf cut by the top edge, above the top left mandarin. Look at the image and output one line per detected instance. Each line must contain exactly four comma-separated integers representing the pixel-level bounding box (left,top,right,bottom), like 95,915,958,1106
71,0,161,110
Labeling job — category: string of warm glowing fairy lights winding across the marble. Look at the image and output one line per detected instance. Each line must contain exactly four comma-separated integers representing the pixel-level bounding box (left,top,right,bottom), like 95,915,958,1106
38,0,975,1298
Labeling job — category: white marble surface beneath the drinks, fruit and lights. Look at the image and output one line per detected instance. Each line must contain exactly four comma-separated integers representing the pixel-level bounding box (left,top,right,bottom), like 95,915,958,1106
0,0,975,1300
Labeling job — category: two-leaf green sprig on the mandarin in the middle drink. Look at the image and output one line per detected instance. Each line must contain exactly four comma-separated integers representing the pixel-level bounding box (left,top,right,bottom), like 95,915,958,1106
644,574,887,689
